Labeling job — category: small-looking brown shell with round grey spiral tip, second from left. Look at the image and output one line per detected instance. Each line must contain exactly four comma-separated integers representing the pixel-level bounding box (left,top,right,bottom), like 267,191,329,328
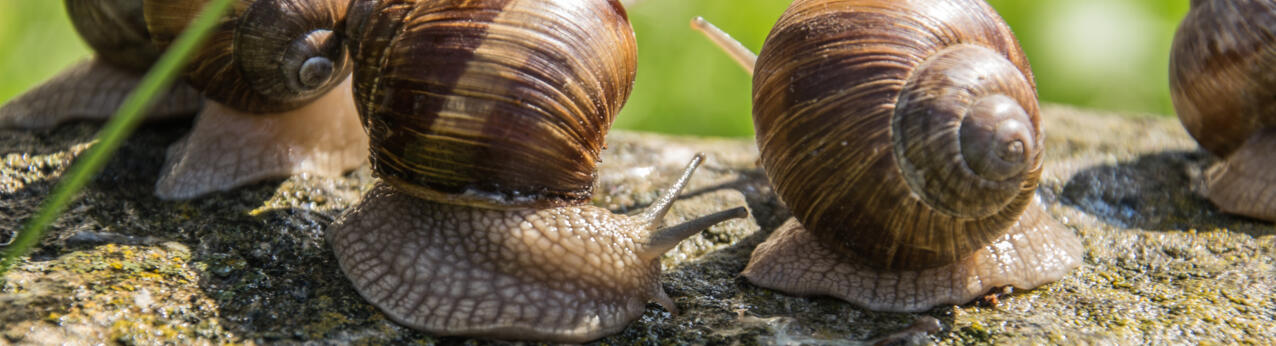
144,0,351,114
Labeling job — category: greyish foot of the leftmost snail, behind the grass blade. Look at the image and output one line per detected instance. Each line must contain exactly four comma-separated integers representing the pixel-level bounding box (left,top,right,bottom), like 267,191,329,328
0,57,203,129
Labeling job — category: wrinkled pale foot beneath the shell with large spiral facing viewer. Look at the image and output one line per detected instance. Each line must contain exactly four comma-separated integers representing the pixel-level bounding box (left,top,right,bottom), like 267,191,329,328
743,200,1083,312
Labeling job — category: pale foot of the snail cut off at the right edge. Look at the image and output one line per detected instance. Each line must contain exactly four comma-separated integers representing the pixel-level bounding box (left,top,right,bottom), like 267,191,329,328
1203,129,1276,221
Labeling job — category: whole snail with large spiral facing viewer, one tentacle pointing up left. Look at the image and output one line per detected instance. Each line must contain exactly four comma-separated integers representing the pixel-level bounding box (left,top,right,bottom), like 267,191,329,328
693,0,1082,312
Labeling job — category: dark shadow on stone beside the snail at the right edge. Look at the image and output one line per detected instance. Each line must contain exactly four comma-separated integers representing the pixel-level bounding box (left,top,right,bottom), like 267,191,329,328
1059,151,1273,236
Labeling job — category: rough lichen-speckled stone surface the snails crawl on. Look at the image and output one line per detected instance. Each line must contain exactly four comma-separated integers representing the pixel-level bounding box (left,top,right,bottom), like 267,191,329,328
0,106,1276,345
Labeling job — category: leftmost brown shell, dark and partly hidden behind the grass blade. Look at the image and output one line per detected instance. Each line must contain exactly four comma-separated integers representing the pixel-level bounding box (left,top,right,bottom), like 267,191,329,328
66,0,160,71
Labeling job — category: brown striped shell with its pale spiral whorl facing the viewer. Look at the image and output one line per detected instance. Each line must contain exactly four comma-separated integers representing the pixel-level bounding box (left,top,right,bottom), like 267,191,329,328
753,0,1042,271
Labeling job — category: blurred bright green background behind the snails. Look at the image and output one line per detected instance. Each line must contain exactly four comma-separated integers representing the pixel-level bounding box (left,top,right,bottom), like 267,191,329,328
0,0,1188,137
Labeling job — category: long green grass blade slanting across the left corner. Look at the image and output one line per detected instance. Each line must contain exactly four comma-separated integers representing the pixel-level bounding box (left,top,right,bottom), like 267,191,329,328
0,0,231,277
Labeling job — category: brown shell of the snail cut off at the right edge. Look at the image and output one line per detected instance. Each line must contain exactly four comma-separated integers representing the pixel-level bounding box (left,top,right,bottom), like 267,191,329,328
1170,0,1276,157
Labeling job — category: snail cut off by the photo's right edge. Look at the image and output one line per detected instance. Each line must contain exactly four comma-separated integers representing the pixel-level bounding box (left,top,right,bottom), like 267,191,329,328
1170,0,1276,221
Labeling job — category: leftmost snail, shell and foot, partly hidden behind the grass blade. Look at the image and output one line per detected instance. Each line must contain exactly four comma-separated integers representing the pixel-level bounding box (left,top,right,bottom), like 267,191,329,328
0,0,202,129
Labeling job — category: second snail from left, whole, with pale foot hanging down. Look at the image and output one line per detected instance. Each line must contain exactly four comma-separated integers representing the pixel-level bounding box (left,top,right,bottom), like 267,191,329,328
143,0,367,199
